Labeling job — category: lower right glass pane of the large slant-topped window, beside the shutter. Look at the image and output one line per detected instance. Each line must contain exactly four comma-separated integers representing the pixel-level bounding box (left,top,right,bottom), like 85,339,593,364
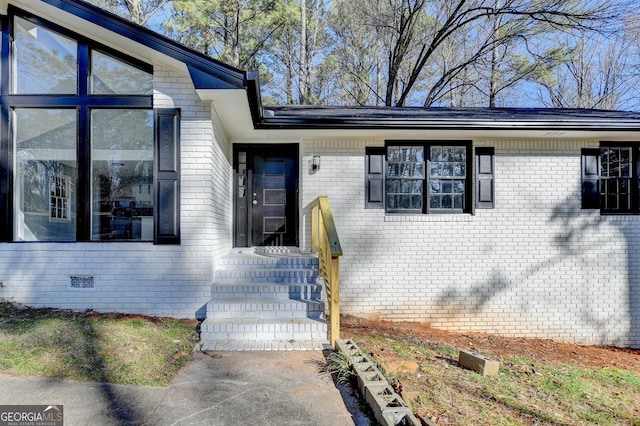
91,110,153,241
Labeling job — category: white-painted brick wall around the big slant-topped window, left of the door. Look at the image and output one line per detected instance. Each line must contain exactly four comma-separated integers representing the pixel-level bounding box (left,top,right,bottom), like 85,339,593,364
0,67,231,318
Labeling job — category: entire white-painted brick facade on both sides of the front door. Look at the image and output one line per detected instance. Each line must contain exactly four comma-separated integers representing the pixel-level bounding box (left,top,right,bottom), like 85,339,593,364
0,67,640,346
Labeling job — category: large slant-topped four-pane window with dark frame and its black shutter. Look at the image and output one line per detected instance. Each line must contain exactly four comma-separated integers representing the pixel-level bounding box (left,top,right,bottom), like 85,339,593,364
0,8,179,244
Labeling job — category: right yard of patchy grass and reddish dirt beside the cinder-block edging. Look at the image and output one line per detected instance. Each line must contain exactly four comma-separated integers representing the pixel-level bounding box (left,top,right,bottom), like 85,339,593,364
342,317,640,426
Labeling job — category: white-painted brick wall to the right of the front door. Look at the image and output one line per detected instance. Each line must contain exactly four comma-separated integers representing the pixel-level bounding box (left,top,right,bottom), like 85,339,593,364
302,139,640,346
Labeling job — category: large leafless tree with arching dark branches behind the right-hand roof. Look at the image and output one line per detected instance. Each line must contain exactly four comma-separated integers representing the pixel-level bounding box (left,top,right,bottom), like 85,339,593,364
344,0,632,106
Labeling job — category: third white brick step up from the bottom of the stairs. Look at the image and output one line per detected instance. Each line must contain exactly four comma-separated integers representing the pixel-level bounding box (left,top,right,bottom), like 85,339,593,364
211,283,323,300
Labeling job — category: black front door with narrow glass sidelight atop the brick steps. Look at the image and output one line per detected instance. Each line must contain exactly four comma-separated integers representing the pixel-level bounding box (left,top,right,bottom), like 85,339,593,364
234,144,298,247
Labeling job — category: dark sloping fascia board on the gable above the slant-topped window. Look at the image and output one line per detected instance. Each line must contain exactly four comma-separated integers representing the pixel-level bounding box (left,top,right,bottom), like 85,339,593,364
41,0,247,89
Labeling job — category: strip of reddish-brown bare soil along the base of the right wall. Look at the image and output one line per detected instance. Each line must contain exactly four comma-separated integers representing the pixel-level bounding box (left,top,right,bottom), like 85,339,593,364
342,316,640,370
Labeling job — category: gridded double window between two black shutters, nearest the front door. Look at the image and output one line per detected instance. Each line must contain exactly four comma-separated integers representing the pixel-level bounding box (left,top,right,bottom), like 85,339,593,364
385,141,471,213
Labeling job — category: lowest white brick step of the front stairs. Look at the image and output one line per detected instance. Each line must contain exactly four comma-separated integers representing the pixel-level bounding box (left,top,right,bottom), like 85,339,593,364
200,318,328,342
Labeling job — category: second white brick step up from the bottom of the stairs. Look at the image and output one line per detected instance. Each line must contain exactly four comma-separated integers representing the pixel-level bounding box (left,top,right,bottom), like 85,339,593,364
207,297,324,319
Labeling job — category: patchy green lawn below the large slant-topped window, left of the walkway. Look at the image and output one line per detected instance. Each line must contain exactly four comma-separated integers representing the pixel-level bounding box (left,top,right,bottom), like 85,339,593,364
0,300,198,386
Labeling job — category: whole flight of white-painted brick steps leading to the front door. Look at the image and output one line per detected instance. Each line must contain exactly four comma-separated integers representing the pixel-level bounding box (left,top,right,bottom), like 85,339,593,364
200,248,329,350
